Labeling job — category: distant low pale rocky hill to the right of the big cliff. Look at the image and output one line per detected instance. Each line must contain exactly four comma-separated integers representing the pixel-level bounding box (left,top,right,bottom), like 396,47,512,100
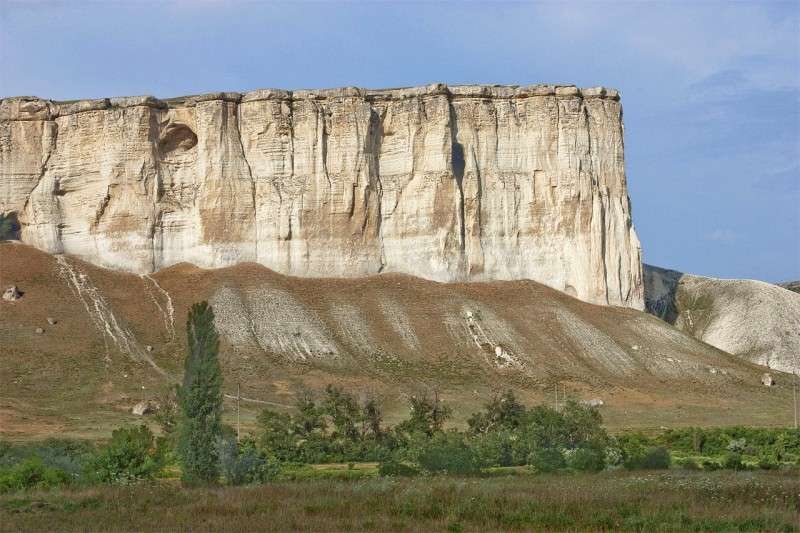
644,265,800,372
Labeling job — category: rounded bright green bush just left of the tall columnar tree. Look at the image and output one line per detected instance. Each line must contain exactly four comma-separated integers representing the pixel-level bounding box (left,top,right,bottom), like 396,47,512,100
87,424,163,484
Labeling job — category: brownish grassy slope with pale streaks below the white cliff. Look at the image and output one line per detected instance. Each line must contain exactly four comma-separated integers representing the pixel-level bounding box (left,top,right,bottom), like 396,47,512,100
0,243,792,439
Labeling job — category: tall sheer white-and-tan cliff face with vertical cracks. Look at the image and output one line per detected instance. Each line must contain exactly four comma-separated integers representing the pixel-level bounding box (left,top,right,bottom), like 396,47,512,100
0,85,644,309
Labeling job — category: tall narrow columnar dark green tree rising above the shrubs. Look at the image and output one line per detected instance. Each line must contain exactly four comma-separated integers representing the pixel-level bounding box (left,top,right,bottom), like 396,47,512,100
178,302,222,484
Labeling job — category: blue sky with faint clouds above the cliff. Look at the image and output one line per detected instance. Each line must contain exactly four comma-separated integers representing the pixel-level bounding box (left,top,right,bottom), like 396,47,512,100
0,0,800,281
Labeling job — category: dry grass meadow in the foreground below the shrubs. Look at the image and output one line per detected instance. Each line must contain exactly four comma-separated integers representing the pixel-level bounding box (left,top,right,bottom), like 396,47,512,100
0,472,800,531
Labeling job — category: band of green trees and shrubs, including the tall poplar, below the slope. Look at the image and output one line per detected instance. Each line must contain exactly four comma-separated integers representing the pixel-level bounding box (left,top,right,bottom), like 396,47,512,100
0,302,800,491
